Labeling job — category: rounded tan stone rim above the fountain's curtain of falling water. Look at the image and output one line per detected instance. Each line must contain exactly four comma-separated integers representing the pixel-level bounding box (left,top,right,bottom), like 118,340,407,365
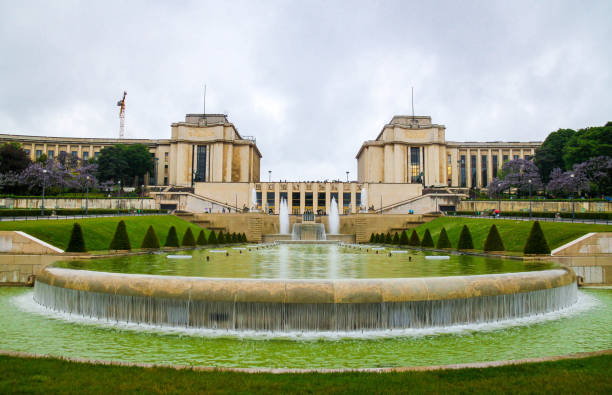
37,267,575,304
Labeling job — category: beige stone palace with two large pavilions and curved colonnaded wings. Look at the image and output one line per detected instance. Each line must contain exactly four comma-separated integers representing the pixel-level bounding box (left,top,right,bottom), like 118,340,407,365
0,114,540,214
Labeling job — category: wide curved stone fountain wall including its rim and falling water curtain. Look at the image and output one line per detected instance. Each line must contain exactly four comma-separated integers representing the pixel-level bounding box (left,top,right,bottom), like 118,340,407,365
34,268,577,331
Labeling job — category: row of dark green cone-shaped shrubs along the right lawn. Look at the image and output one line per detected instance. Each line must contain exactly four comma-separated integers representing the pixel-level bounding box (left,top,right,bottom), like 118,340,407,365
370,221,550,254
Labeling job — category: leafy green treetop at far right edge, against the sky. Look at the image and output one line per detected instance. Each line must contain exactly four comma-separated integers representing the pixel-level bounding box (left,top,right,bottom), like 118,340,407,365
563,124,612,169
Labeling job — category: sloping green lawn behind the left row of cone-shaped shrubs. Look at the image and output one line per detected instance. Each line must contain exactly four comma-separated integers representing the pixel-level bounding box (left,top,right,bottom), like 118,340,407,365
0,215,208,251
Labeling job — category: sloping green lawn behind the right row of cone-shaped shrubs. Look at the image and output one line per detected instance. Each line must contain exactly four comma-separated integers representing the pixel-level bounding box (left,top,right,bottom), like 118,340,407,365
408,217,612,252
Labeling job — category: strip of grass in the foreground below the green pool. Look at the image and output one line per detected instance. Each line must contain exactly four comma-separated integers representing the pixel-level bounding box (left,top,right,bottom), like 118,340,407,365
0,355,612,394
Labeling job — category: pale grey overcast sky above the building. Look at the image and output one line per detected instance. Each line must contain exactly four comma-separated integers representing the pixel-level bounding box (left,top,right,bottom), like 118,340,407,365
0,0,612,180
